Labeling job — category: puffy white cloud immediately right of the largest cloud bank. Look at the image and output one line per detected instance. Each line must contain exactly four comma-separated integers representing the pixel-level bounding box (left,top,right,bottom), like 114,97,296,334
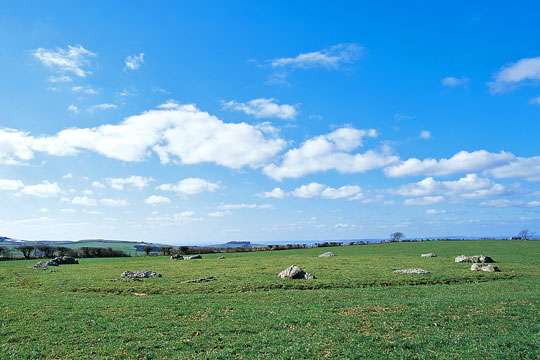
263,128,398,181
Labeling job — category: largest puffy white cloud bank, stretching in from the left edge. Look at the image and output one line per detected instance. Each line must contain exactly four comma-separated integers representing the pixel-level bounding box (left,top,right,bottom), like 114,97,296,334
0,105,285,169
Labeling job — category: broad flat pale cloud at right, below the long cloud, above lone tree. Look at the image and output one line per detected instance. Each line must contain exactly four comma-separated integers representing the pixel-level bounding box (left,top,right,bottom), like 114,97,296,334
390,174,506,199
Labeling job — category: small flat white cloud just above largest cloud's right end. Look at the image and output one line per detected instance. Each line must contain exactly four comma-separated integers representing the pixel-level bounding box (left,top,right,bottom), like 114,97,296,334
222,98,298,120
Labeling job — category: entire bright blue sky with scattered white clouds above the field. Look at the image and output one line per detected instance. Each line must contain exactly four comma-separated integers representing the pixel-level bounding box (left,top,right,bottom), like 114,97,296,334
0,1,540,244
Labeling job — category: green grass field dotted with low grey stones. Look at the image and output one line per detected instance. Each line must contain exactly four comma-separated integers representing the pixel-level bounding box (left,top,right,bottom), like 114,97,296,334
0,241,540,359
